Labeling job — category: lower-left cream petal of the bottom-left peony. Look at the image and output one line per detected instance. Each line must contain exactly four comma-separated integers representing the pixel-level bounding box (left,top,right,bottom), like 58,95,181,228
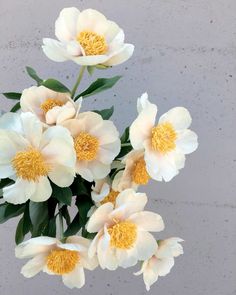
21,254,46,278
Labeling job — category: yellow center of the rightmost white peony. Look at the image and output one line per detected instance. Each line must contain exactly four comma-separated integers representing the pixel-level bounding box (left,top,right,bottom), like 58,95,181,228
151,122,177,154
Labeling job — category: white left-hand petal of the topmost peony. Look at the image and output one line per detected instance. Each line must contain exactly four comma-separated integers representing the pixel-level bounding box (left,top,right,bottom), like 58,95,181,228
42,38,70,62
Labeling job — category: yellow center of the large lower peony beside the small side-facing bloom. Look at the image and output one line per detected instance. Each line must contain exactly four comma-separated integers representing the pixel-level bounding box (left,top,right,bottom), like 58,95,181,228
108,221,137,250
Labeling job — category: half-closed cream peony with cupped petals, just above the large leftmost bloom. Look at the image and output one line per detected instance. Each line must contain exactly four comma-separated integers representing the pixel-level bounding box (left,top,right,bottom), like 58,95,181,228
20,86,82,125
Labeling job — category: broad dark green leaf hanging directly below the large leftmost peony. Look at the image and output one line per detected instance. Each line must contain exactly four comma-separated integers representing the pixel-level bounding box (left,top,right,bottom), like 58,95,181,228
29,201,48,237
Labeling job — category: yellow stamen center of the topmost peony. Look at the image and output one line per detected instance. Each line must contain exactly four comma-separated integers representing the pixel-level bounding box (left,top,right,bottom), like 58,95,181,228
77,31,108,55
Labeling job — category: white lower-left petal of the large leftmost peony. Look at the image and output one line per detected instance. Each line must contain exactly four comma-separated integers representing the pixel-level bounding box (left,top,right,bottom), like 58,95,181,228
3,178,36,204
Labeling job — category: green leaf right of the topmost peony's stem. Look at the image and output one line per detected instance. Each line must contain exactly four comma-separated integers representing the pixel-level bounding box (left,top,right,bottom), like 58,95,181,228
75,76,121,100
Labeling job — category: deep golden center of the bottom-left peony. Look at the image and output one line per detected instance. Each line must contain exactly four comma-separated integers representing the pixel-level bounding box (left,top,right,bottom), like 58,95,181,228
47,249,80,275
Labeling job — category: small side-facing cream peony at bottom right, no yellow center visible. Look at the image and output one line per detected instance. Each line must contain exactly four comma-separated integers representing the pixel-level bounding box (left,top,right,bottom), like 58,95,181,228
135,238,183,291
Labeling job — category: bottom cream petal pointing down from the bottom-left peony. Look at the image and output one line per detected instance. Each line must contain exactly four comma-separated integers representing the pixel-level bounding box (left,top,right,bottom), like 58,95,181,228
62,264,85,289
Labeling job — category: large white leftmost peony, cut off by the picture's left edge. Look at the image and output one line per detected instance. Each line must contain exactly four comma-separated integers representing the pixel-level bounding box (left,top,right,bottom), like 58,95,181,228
0,113,76,204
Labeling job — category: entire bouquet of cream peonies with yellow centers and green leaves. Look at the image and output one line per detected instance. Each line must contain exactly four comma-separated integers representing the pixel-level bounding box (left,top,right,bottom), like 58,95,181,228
0,7,198,290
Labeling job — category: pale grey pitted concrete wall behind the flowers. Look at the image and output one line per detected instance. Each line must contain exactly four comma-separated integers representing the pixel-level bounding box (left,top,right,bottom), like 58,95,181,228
0,0,236,295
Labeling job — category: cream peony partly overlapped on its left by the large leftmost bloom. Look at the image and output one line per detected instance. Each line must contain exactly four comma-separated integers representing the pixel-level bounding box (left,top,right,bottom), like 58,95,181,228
63,112,120,182
